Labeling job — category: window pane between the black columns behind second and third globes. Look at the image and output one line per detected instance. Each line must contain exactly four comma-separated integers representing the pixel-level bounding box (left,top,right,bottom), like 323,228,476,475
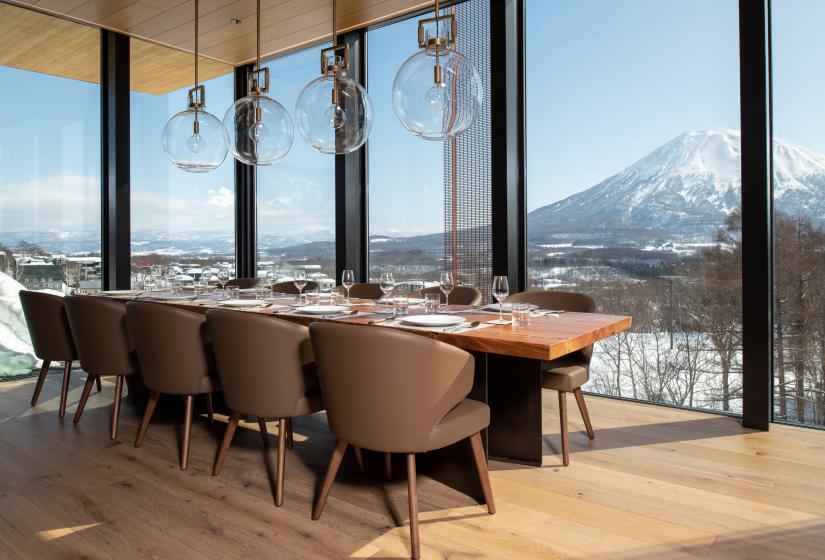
257,45,335,286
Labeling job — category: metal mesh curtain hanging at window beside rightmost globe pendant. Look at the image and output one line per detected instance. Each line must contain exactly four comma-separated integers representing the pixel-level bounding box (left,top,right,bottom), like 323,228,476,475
444,0,493,301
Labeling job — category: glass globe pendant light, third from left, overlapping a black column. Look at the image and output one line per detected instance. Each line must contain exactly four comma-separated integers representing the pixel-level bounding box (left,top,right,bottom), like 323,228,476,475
295,0,372,154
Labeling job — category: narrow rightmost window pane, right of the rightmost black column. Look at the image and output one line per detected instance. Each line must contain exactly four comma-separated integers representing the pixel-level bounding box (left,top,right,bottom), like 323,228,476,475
771,0,825,426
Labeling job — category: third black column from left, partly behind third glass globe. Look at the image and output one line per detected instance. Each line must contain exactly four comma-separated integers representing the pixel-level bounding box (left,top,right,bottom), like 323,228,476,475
335,30,369,282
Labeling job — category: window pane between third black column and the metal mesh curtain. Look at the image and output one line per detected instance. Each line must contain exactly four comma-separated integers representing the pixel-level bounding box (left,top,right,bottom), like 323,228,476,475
367,16,444,283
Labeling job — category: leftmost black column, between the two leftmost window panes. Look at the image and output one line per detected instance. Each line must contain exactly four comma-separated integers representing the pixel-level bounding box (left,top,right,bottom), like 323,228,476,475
100,29,131,290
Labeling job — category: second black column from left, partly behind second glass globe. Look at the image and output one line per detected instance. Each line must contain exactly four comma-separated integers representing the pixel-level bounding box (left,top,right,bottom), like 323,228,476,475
233,64,258,278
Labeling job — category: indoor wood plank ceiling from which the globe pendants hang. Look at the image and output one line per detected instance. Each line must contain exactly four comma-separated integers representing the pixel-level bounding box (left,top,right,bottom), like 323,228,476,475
6,0,433,66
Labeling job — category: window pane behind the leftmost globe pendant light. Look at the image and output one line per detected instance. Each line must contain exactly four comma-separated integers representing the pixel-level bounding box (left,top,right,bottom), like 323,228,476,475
130,39,235,279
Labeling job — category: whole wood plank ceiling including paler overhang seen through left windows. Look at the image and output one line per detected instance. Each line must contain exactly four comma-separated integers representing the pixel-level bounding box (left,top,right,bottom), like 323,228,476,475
0,0,433,95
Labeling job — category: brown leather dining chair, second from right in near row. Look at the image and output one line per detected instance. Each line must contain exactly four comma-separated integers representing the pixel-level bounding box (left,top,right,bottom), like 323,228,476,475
206,309,324,507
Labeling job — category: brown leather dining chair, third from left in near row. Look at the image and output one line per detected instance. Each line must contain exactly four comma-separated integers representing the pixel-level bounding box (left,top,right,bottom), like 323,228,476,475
126,301,220,470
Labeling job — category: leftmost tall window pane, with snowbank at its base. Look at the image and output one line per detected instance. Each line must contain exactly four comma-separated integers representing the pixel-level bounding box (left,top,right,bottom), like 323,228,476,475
0,4,100,377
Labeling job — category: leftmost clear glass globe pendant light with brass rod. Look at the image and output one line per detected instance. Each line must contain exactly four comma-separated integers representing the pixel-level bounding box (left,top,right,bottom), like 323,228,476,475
163,0,226,173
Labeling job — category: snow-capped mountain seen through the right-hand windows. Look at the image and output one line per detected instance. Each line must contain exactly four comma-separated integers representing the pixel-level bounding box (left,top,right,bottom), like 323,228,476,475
528,128,825,243
